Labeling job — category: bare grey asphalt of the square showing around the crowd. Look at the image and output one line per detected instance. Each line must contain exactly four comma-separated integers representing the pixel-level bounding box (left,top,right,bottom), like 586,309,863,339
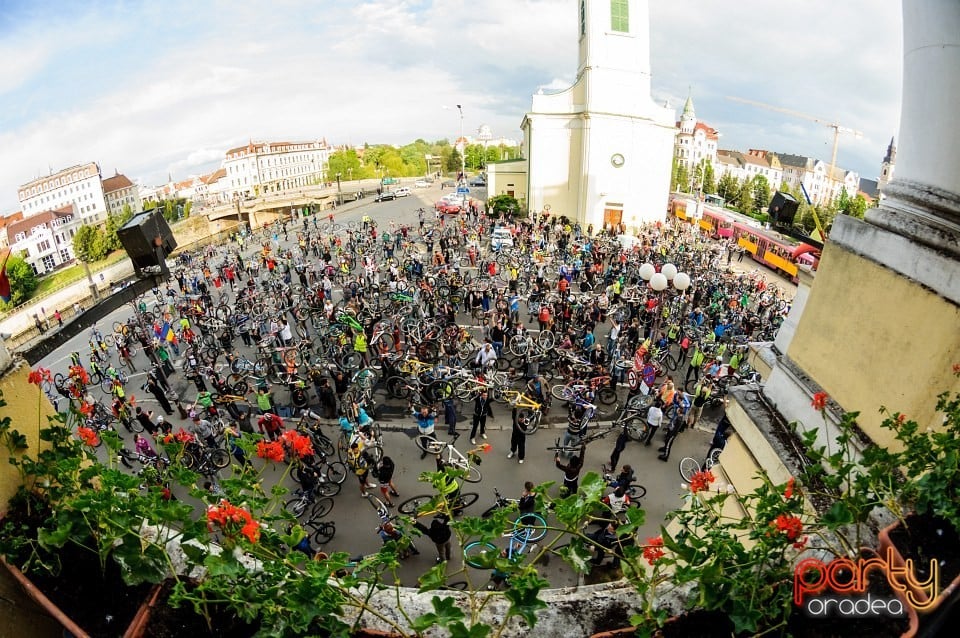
33,186,746,587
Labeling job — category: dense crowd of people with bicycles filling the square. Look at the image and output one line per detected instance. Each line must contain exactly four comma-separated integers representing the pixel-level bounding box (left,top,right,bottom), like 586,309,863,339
48,198,789,584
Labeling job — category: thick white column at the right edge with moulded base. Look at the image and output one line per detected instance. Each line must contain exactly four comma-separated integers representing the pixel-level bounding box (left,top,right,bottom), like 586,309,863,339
866,0,960,255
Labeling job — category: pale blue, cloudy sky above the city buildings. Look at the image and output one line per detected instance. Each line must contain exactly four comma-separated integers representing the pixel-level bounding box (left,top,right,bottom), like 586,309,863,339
0,0,903,214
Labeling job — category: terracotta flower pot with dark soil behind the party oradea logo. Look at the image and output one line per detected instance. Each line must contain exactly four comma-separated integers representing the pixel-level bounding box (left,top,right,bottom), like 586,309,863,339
879,514,960,614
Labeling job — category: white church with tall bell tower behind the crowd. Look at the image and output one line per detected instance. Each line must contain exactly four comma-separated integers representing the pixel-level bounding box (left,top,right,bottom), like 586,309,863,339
521,0,676,230
